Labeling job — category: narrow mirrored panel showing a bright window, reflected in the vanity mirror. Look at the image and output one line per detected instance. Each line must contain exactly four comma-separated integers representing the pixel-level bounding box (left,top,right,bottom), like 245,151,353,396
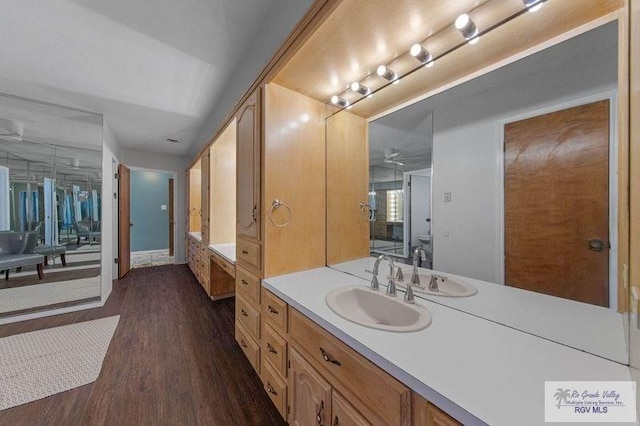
368,108,432,266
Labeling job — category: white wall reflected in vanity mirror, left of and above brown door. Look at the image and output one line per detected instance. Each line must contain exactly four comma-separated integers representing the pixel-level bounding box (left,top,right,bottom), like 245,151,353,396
431,25,617,282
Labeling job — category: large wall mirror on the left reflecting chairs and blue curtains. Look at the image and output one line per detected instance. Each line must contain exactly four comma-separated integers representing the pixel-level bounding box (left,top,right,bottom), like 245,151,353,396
0,95,102,318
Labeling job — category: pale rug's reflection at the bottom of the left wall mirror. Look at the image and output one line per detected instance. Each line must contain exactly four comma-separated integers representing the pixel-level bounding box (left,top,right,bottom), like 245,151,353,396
0,275,101,313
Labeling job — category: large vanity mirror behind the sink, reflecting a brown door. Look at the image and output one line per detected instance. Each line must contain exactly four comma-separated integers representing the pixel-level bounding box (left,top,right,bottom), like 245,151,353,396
326,18,629,364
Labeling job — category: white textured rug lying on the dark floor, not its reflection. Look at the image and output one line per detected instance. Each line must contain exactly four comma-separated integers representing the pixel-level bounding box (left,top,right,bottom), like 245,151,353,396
0,316,120,410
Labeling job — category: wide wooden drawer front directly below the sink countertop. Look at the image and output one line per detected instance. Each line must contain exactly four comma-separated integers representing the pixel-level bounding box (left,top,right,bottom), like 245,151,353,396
289,309,411,425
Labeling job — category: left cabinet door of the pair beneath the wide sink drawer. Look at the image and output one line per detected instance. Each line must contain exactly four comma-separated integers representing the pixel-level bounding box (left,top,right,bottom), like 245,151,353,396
289,349,331,426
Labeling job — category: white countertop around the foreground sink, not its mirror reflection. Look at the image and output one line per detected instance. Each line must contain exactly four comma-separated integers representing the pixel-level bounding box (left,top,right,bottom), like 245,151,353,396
263,267,631,426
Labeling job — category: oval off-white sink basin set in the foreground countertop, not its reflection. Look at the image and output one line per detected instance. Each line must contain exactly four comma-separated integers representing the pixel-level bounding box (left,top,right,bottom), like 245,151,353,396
326,286,431,332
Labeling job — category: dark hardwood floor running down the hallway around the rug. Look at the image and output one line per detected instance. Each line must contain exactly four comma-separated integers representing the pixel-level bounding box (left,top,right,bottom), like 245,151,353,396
0,265,285,426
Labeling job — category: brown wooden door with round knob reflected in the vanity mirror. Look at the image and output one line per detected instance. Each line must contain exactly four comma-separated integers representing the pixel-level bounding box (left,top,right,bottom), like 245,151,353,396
504,100,609,306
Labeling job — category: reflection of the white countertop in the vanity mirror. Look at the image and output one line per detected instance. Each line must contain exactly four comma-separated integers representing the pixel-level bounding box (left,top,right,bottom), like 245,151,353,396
331,257,629,364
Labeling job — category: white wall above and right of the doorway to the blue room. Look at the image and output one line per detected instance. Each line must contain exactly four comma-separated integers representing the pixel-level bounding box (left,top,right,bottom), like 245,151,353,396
120,148,191,263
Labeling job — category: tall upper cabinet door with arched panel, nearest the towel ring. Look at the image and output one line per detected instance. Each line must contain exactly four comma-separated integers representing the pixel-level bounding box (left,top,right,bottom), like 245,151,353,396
236,89,261,241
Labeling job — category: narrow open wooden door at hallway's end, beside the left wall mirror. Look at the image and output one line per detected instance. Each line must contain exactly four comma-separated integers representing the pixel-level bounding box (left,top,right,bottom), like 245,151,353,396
118,164,132,278
